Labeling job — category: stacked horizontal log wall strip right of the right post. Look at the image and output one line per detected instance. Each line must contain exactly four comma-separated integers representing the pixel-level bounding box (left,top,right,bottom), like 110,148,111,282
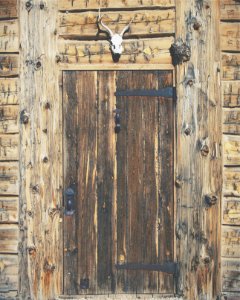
220,0,240,299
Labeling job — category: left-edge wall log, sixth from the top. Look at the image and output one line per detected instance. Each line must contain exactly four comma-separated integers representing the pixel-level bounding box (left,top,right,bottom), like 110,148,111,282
0,134,19,160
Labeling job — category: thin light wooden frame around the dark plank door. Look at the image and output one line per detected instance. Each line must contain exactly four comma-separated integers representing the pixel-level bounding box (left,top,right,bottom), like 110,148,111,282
59,64,176,300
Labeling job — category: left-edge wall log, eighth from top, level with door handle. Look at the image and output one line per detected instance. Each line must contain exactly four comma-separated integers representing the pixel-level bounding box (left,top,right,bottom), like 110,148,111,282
0,196,19,223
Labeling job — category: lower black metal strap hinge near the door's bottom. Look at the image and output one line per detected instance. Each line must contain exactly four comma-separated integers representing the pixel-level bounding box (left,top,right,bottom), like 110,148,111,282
115,262,179,276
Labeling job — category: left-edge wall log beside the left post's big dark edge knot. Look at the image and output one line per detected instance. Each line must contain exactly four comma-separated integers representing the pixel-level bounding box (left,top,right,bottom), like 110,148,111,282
0,105,19,133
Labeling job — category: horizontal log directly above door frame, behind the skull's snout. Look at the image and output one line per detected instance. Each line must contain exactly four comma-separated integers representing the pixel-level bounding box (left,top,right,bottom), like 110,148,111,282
59,37,174,65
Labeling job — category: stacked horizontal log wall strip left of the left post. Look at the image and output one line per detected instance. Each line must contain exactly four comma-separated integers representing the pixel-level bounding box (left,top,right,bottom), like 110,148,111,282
0,0,19,299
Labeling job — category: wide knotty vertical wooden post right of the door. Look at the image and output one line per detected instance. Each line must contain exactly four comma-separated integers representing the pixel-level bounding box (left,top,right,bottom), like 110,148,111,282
175,0,221,299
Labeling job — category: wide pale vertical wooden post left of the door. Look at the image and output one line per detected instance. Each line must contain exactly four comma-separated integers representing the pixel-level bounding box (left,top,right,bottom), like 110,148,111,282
19,0,63,299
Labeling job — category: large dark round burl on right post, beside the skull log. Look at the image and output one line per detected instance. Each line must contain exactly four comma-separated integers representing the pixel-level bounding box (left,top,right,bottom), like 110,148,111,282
170,39,191,66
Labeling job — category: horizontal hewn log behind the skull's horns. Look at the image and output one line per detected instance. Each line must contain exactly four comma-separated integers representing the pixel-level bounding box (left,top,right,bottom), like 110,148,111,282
59,9,175,39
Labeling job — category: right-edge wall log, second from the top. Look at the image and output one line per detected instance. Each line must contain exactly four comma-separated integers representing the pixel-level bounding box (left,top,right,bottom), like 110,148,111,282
220,23,240,51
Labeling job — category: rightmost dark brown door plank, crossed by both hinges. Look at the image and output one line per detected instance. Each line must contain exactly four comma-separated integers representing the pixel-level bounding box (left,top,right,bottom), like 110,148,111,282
158,72,174,293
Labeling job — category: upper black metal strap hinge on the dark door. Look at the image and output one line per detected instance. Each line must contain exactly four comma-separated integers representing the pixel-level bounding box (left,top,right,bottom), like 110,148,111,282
115,87,174,98
